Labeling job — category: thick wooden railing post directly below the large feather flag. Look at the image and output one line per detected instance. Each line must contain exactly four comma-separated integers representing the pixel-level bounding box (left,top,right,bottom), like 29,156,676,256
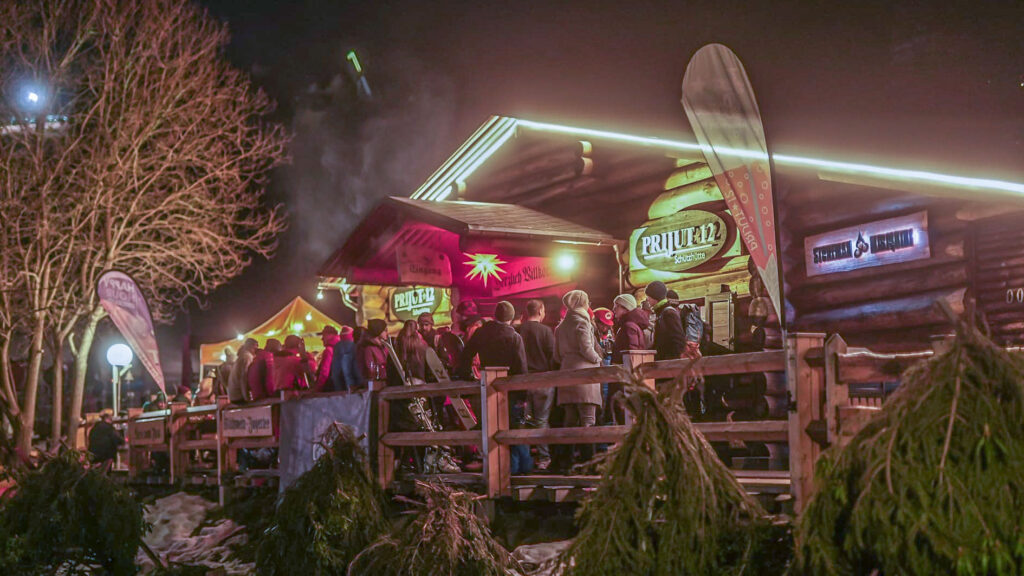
785,333,825,513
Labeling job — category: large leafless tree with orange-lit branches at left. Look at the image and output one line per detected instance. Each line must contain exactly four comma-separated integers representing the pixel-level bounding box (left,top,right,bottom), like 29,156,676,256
0,0,286,457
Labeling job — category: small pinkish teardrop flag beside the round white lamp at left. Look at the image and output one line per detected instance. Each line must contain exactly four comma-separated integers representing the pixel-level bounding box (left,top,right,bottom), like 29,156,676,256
96,271,167,395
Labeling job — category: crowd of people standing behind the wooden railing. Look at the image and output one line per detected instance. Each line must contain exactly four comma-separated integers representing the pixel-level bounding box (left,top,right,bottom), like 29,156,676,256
125,282,705,470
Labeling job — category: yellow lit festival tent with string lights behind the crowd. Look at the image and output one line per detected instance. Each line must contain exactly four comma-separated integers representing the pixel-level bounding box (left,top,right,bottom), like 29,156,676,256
199,296,350,366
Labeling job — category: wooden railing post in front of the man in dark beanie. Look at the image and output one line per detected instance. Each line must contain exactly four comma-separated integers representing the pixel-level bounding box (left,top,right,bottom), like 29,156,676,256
480,366,512,498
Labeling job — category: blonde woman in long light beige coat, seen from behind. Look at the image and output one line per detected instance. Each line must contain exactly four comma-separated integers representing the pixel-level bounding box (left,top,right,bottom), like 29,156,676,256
555,290,601,461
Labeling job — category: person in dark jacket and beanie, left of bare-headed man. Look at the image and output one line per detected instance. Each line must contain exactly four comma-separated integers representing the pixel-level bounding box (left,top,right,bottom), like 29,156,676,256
456,301,527,379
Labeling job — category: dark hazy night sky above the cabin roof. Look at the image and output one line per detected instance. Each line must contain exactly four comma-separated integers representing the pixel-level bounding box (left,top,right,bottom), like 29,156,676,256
151,0,1024,381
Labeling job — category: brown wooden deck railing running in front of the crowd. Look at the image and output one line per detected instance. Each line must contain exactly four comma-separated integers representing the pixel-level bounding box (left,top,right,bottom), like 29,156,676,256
110,334,931,510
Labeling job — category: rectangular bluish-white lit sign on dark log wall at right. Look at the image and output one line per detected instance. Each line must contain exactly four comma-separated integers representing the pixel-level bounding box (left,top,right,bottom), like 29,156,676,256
804,212,931,276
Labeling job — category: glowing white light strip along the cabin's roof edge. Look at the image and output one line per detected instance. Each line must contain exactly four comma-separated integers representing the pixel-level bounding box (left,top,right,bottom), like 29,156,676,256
412,116,1024,201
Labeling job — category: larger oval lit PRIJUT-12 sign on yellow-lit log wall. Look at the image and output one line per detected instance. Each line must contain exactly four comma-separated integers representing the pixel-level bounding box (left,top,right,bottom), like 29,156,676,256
630,210,729,272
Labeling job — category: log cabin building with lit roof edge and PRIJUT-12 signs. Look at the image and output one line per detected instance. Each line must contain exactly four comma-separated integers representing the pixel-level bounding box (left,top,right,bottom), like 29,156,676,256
321,117,1024,352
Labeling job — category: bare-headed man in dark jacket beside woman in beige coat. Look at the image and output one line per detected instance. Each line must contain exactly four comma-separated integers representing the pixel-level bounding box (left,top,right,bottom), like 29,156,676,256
519,300,555,470
